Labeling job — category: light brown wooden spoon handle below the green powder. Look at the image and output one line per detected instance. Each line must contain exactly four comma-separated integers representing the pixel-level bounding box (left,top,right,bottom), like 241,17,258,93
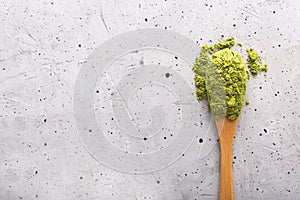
215,118,238,200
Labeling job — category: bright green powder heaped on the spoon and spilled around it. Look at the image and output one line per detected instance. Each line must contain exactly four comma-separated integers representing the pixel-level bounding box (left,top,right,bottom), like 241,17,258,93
193,37,267,120
